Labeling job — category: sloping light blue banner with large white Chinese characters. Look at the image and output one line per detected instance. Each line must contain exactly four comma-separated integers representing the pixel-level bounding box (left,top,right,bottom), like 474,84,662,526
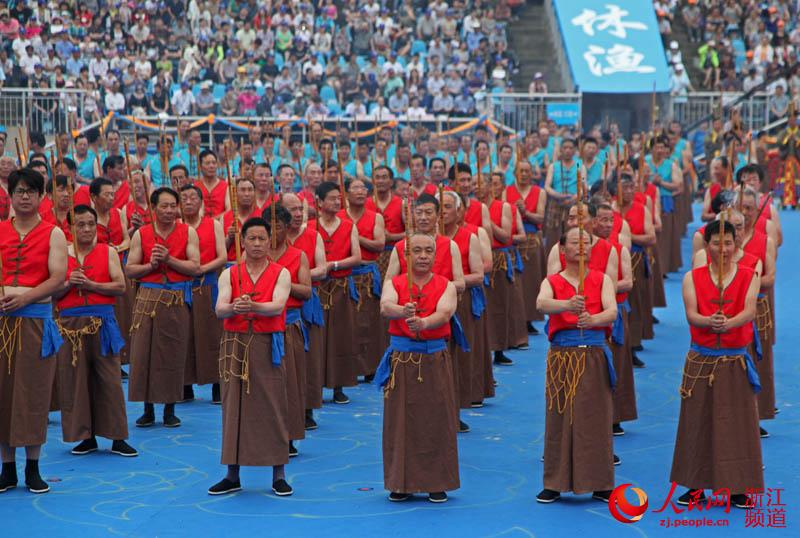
553,0,669,93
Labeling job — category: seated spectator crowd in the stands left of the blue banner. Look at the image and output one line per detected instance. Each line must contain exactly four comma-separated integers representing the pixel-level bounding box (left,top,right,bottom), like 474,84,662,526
0,0,521,129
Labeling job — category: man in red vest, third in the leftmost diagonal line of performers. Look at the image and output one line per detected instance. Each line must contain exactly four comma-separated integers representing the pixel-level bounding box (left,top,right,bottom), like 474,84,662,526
125,187,200,428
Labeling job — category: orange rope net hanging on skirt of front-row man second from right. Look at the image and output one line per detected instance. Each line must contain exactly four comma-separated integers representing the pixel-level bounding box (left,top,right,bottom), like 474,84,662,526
545,348,586,424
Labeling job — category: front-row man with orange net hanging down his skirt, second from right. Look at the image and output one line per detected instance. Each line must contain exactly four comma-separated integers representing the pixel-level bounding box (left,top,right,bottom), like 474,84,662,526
536,228,617,503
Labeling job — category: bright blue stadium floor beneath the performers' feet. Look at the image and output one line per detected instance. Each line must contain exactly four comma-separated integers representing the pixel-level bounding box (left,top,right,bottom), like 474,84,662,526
0,203,800,537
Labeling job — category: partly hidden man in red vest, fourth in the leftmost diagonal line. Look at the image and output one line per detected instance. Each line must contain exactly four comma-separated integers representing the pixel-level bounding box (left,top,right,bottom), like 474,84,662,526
181,184,228,404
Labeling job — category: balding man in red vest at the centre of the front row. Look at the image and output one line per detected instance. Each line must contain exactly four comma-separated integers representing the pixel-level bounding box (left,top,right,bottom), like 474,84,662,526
375,232,460,503
